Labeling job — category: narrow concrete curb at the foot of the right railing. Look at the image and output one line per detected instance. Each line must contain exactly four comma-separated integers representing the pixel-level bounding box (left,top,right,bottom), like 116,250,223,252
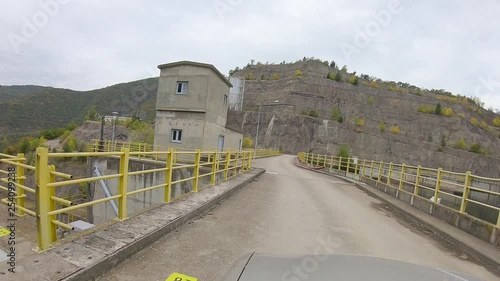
296,162,500,276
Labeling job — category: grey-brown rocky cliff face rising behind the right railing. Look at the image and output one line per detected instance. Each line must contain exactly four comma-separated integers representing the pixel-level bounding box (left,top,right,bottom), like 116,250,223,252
228,62,500,177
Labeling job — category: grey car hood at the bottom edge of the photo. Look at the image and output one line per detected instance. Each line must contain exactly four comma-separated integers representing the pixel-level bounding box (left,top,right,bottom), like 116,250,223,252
222,253,481,281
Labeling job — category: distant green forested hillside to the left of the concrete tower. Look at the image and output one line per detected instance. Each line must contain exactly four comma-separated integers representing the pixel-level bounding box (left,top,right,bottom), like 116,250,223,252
0,78,158,137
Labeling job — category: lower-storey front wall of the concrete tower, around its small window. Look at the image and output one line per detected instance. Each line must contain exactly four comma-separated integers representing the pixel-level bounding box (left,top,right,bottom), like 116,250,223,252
154,111,205,149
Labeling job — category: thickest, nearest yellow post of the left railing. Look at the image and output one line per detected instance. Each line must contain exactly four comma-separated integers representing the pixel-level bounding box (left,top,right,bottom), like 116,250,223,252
35,147,57,251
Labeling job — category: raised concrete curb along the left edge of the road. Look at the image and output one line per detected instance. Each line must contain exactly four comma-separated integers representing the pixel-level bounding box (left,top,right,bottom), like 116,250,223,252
49,168,265,281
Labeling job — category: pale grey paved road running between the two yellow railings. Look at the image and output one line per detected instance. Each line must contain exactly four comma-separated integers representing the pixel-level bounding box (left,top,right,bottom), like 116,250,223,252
98,156,498,281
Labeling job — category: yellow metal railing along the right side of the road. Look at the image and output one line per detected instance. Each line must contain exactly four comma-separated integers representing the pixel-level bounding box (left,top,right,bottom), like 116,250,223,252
298,152,500,227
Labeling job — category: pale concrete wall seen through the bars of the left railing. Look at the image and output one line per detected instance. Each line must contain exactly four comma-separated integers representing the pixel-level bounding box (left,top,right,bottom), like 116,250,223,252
90,158,232,225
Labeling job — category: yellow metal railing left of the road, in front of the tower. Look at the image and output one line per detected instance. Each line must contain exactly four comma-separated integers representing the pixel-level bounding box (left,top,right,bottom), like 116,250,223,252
0,142,268,251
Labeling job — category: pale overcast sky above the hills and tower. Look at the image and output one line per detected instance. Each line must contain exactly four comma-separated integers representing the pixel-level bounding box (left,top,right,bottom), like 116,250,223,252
0,0,500,108
